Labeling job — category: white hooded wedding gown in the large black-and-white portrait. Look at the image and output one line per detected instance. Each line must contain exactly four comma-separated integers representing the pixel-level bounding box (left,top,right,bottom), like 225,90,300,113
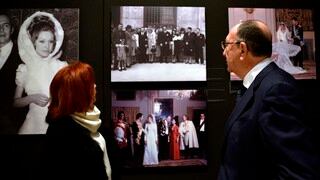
16,11,67,134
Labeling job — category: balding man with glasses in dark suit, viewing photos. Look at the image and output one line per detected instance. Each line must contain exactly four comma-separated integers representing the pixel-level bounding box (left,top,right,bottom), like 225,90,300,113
218,20,320,180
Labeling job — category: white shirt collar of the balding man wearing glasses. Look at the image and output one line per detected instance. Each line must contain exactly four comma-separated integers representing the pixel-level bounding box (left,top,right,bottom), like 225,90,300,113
243,58,272,89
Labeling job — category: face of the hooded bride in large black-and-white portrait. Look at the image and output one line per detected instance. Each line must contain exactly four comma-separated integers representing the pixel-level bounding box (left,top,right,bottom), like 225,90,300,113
34,31,54,58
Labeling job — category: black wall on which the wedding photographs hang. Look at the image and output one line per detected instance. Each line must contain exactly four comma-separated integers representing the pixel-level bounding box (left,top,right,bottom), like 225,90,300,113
0,0,320,180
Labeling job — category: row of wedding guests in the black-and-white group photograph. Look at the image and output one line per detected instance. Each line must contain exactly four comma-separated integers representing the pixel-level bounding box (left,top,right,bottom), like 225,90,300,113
111,24,206,71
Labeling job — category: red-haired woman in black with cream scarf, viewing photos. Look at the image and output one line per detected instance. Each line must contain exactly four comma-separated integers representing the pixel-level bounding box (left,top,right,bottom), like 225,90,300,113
46,61,111,180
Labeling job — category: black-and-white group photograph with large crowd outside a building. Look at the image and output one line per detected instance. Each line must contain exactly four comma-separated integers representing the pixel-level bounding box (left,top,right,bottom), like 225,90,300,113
108,6,206,82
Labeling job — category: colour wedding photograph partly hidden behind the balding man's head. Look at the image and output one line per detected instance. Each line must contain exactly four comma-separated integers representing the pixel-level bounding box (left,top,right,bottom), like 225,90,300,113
228,8,316,80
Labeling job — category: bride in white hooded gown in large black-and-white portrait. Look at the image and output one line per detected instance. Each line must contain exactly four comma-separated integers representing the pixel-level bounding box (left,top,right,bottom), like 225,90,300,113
14,12,67,134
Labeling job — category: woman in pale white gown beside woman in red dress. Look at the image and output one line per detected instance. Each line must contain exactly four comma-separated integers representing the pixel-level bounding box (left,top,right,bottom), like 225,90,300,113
143,114,159,165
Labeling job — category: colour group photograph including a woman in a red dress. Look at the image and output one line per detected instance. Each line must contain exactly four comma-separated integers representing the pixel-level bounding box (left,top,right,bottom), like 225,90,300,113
111,89,208,168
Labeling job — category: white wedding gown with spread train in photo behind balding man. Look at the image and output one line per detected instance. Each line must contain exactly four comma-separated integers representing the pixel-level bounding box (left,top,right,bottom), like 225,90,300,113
272,42,307,74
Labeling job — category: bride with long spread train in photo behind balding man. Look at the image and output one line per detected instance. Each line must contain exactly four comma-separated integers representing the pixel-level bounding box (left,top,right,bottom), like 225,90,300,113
272,22,306,74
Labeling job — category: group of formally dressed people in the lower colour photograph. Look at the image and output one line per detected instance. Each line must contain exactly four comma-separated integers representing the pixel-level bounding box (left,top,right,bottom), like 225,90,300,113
114,111,207,166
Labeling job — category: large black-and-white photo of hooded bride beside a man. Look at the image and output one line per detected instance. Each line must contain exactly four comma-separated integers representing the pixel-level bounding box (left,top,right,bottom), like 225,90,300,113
0,8,79,134
